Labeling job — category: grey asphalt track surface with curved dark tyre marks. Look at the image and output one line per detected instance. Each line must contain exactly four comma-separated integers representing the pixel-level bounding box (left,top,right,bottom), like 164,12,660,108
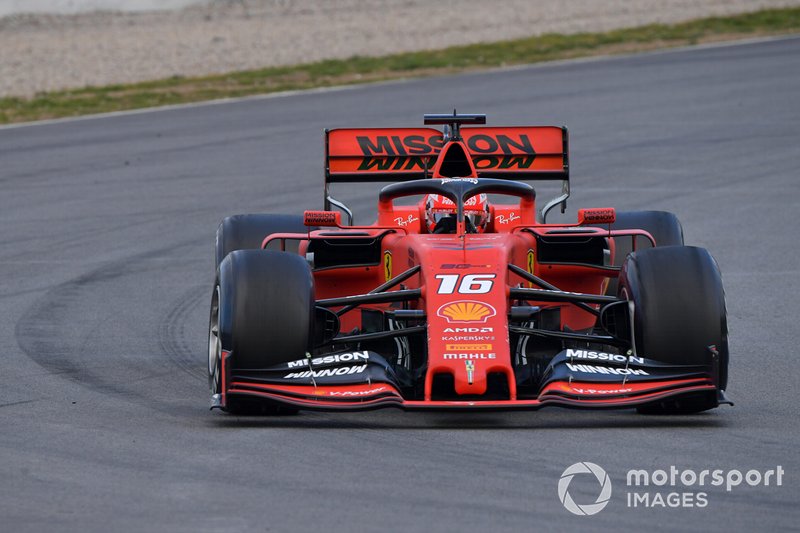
0,38,800,532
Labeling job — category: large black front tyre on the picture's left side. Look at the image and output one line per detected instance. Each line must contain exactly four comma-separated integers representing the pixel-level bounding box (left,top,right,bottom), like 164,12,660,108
209,250,314,413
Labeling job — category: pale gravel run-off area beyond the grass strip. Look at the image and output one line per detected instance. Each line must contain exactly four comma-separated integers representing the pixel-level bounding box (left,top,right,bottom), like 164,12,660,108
0,0,800,96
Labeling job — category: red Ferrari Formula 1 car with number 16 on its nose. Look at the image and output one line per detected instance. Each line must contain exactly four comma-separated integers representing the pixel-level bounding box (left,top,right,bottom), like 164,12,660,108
208,113,730,413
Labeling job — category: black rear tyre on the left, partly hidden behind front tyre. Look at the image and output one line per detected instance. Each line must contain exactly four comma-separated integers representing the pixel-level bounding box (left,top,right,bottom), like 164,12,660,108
214,214,314,267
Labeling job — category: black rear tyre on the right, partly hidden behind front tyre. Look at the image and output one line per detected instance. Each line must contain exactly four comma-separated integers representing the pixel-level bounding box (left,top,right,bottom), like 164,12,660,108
598,211,683,296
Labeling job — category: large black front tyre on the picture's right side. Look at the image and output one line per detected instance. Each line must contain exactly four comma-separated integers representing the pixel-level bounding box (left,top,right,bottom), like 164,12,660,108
619,246,729,414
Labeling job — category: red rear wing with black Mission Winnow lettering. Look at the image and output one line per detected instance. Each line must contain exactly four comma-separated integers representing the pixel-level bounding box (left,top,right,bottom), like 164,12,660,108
325,117,569,218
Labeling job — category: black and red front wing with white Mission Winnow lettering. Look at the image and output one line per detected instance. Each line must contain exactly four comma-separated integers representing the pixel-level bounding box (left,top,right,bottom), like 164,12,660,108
211,350,731,411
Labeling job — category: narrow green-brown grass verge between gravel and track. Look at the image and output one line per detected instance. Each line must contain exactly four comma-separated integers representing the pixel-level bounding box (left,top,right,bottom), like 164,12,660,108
0,8,800,124
